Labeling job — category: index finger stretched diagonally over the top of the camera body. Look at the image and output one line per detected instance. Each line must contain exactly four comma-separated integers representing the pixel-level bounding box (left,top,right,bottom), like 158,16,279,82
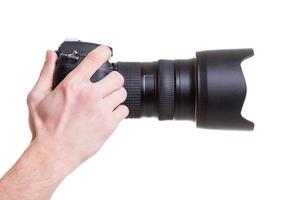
69,45,112,81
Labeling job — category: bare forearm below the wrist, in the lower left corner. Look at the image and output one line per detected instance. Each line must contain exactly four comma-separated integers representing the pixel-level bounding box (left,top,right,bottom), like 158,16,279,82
0,141,73,200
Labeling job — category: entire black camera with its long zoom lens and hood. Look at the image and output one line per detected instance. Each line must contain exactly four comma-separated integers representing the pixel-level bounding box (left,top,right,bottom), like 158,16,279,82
53,41,254,130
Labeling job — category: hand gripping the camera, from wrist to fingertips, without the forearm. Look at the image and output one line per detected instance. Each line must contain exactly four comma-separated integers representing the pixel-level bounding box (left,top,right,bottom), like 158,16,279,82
28,45,129,167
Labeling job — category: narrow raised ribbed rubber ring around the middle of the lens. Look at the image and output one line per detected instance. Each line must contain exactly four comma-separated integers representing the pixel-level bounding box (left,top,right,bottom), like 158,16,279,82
158,60,175,120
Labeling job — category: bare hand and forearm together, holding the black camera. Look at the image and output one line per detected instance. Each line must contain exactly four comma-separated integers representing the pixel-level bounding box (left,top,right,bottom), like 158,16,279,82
0,45,129,200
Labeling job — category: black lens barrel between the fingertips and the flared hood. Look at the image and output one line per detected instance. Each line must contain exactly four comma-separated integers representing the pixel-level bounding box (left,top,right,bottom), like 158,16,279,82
116,59,195,120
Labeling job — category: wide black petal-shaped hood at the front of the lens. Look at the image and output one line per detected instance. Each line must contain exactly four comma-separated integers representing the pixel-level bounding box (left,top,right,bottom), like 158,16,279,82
196,49,254,130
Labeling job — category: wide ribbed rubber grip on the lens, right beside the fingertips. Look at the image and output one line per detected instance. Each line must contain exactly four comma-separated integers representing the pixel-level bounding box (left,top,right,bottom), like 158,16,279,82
117,62,142,118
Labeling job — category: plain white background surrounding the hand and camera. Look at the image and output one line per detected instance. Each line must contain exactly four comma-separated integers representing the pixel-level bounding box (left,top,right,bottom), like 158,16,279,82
0,0,301,200
